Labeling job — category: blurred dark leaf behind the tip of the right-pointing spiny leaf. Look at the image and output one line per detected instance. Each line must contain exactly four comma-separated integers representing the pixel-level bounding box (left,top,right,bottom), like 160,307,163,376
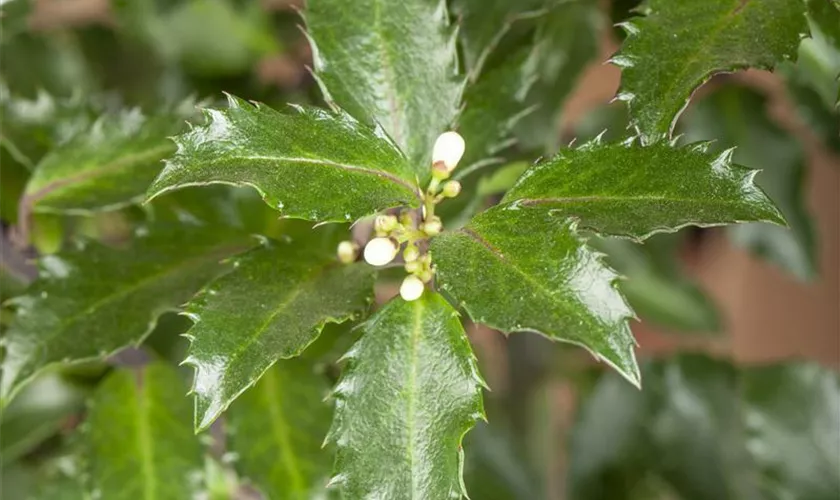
684,86,817,280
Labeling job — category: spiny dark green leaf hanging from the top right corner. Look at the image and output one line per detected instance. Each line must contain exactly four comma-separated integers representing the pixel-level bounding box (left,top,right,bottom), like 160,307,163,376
612,0,808,143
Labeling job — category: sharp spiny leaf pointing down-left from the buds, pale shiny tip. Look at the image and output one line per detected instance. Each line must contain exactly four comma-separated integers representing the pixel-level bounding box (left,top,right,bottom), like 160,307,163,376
184,235,374,429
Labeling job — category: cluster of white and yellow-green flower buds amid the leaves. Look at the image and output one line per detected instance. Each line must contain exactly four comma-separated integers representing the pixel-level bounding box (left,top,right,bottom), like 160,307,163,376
338,132,465,301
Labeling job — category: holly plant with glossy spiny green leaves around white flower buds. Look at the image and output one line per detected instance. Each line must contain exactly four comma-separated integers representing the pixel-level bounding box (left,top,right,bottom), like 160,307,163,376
0,0,838,500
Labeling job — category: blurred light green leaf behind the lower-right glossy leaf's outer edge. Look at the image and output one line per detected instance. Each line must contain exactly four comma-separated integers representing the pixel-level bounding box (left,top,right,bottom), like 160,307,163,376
591,235,722,333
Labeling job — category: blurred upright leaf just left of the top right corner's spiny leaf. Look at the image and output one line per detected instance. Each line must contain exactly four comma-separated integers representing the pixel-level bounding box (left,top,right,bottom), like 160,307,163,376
514,0,605,153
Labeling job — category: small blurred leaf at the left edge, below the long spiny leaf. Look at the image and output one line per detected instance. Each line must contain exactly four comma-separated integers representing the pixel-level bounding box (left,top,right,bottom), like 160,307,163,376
0,374,84,466
